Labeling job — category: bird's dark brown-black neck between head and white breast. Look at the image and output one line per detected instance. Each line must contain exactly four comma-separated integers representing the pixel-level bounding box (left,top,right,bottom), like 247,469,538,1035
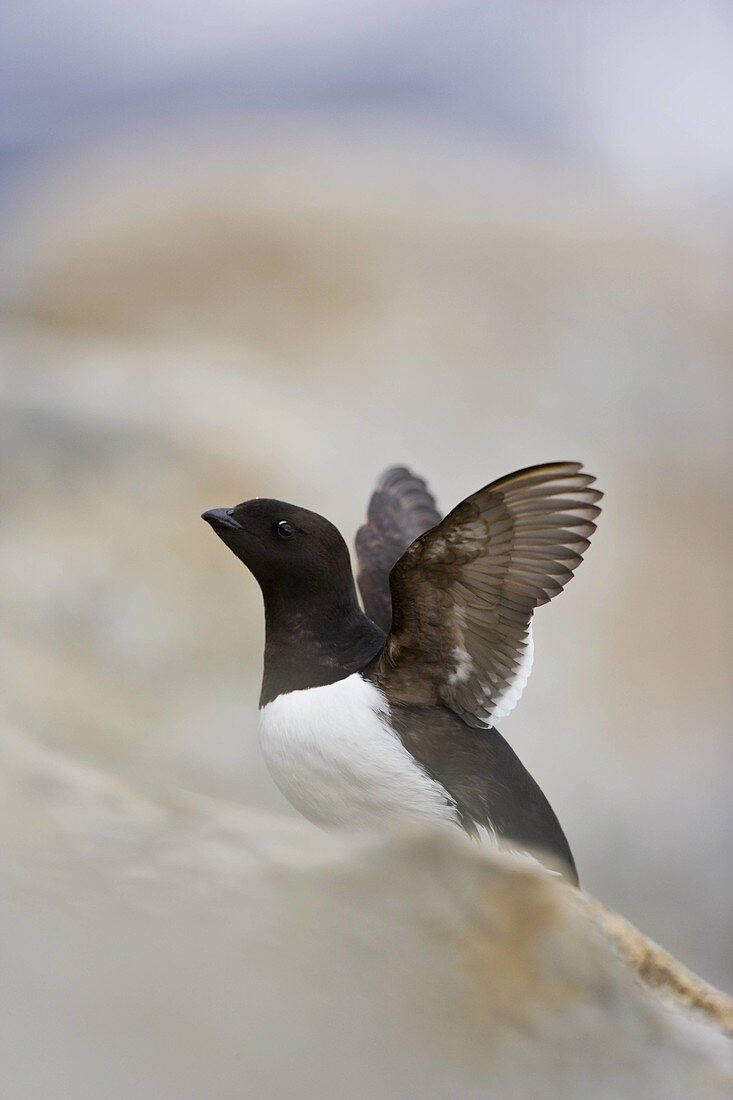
260,584,385,706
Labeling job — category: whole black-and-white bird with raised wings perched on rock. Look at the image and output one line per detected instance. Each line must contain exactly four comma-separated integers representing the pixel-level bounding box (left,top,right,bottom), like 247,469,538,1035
201,462,602,886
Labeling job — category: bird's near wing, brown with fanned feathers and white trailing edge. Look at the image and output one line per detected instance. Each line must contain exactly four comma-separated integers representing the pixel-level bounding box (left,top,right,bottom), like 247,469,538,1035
373,462,602,727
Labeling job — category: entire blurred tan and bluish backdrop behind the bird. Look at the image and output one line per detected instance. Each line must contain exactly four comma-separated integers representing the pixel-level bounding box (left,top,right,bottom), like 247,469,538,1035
0,0,733,1007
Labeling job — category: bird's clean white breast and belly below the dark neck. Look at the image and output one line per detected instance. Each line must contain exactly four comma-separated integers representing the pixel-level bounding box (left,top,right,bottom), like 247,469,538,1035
260,673,457,829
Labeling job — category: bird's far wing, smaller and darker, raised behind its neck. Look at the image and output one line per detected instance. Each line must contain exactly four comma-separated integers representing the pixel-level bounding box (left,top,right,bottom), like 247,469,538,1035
357,466,440,634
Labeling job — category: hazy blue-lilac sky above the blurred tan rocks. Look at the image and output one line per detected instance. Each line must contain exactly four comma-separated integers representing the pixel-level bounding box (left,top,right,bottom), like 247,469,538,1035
0,0,733,194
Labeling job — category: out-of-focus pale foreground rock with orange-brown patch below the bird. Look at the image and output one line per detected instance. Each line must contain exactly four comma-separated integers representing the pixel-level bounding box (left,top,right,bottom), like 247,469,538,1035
0,734,733,1100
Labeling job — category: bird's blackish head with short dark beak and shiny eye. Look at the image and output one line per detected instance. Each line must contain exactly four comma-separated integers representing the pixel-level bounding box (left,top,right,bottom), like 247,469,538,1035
201,498,355,598
